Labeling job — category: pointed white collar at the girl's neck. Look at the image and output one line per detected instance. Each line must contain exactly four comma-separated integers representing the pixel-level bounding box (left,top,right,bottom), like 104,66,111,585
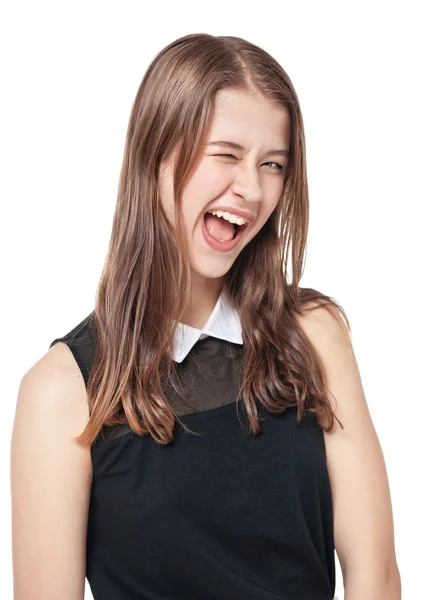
173,293,243,363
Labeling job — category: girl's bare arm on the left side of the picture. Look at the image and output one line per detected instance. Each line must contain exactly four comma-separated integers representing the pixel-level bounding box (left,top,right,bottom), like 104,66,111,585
10,342,92,600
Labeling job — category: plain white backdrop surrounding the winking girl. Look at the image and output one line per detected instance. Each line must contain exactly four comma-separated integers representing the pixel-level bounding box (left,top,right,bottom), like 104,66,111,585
0,0,429,600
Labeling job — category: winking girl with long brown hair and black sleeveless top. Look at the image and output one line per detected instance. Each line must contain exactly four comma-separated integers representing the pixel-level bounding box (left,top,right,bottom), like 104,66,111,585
12,34,400,600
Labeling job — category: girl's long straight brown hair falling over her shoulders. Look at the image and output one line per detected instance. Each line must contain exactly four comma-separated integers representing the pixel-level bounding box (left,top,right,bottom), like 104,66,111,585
76,34,350,445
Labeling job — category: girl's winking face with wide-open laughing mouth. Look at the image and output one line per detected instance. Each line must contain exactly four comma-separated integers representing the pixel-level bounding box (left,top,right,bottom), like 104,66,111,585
160,90,290,283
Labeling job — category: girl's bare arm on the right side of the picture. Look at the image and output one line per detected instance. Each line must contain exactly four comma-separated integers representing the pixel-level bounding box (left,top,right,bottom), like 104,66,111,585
299,307,401,600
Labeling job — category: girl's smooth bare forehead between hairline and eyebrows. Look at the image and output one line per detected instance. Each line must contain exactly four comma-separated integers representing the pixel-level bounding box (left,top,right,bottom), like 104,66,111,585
208,90,290,148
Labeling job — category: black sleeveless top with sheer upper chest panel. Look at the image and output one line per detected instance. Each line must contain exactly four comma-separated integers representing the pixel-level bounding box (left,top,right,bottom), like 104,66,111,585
50,313,335,600
